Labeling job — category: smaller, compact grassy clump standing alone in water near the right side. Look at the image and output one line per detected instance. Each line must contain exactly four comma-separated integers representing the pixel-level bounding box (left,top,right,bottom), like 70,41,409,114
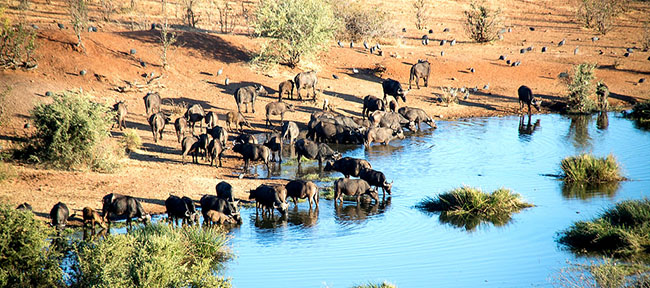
560,154,625,184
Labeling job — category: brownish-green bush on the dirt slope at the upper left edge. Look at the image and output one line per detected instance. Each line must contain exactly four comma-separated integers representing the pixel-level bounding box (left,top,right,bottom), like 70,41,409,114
0,7,37,69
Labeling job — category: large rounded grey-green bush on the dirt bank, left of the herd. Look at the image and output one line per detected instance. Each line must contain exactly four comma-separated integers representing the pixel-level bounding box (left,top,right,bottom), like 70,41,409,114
27,92,116,171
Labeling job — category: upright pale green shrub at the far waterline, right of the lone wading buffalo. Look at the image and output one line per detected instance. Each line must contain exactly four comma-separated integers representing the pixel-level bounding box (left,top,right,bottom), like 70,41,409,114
567,63,596,113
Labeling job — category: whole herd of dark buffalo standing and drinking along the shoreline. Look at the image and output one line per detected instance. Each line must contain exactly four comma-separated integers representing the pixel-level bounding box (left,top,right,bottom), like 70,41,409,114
36,60,450,229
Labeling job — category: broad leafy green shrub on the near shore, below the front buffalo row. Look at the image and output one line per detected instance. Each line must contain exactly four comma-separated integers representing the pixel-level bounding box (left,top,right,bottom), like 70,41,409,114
71,224,230,287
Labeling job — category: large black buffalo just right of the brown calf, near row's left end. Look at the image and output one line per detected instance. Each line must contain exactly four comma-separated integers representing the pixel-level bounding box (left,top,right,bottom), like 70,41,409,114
102,193,151,231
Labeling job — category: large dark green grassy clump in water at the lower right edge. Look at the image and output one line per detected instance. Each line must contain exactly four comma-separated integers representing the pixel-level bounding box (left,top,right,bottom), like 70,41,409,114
558,199,650,257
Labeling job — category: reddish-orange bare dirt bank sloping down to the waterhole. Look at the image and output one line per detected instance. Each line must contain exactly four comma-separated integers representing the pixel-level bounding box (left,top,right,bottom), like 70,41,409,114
0,0,650,225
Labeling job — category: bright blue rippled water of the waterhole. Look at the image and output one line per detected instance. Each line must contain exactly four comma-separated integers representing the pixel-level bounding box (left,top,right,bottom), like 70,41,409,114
225,113,650,287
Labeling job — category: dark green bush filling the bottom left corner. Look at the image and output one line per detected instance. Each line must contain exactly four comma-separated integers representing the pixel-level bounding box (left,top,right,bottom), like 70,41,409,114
0,203,63,287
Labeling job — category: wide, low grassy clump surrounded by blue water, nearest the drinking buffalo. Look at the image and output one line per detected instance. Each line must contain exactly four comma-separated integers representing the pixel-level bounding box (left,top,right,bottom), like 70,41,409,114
416,186,533,230
